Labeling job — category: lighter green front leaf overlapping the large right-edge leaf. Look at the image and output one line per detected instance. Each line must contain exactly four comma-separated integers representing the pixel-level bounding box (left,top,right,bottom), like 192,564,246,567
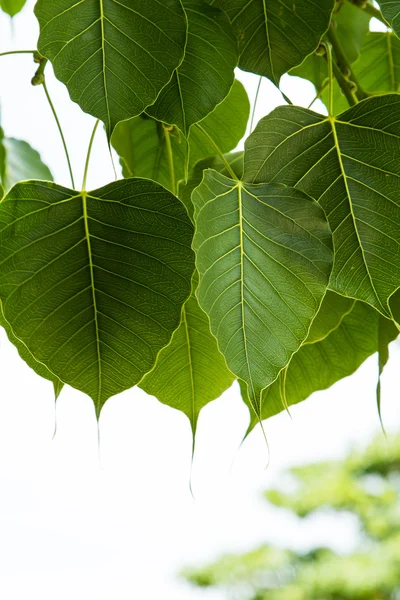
192,170,332,412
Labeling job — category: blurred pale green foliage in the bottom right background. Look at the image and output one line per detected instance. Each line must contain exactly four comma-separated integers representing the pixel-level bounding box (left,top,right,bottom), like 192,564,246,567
183,436,400,600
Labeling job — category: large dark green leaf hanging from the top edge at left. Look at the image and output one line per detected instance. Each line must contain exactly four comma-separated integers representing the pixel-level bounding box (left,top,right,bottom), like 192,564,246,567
35,0,187,138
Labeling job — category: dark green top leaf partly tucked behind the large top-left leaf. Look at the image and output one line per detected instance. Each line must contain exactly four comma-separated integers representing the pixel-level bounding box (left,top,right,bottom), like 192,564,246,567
147,0,238,137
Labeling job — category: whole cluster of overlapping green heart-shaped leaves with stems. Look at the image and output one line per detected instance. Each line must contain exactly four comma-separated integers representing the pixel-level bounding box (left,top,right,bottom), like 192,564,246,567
0,0,400,450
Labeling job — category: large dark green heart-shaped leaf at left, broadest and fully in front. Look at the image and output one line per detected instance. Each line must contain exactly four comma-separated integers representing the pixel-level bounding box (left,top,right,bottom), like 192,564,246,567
0,179,194,414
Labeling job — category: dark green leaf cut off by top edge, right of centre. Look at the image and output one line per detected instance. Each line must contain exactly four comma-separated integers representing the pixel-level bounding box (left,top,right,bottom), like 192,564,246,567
212,0,335,84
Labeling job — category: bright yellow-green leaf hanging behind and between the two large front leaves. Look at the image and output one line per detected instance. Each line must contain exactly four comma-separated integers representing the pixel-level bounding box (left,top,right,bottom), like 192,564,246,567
140,274,235,435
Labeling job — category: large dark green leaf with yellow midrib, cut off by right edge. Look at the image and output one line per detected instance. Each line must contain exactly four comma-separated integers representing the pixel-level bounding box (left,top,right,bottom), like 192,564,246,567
245,94,400,318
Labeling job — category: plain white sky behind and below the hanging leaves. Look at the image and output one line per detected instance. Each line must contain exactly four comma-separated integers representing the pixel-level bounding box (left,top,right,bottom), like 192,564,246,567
0,2,400,600
